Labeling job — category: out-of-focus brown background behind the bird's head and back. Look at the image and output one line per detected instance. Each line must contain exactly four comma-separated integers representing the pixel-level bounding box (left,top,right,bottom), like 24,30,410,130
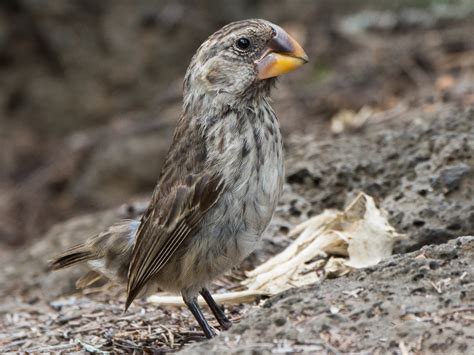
0,0,474,247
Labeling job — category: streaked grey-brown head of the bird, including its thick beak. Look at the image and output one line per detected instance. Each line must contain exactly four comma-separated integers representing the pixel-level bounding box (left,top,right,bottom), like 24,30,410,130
184,19,308,110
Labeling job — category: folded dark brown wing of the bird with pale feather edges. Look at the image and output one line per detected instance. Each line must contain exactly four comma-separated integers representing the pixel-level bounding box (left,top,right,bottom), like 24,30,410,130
125,174,223,309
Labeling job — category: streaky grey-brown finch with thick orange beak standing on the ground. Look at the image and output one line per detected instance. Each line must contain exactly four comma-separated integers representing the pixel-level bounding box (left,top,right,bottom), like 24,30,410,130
50,19,308,338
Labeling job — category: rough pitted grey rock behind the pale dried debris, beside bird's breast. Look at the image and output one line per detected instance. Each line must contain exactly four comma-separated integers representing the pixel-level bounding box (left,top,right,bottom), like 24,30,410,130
287,106,474,252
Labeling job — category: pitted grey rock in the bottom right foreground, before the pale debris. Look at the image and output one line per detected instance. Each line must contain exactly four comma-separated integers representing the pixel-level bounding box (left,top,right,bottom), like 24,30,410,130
180,237,474,354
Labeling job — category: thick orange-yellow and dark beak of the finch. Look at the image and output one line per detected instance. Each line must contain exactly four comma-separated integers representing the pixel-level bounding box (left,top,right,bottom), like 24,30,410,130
256,24,308,80
